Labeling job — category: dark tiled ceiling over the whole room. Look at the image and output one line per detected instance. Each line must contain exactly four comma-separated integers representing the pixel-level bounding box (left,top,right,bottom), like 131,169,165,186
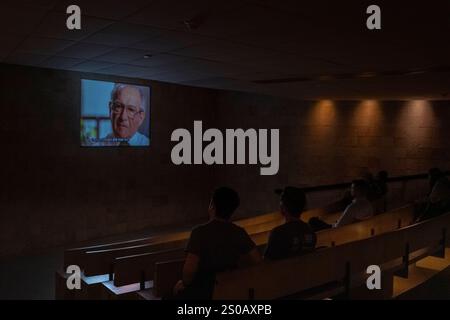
0,0,450,98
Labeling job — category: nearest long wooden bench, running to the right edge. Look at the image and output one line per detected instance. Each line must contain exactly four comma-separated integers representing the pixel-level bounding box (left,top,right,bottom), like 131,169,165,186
214,214,450,300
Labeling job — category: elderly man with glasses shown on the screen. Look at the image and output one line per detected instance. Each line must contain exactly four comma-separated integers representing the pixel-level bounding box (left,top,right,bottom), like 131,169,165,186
100,83,149,146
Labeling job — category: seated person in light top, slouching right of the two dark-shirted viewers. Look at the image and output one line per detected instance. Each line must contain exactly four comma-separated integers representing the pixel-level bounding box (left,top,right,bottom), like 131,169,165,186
334,180,374,228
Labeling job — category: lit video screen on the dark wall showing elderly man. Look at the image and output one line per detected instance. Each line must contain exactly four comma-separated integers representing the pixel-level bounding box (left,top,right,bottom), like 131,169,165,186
80,80,150,147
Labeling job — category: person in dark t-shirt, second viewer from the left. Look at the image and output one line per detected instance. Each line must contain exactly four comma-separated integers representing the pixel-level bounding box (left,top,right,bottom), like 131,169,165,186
264,187,317,260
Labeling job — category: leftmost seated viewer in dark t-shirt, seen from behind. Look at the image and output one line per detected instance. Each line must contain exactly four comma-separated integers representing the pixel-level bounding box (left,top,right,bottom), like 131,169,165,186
172,187,262,300
